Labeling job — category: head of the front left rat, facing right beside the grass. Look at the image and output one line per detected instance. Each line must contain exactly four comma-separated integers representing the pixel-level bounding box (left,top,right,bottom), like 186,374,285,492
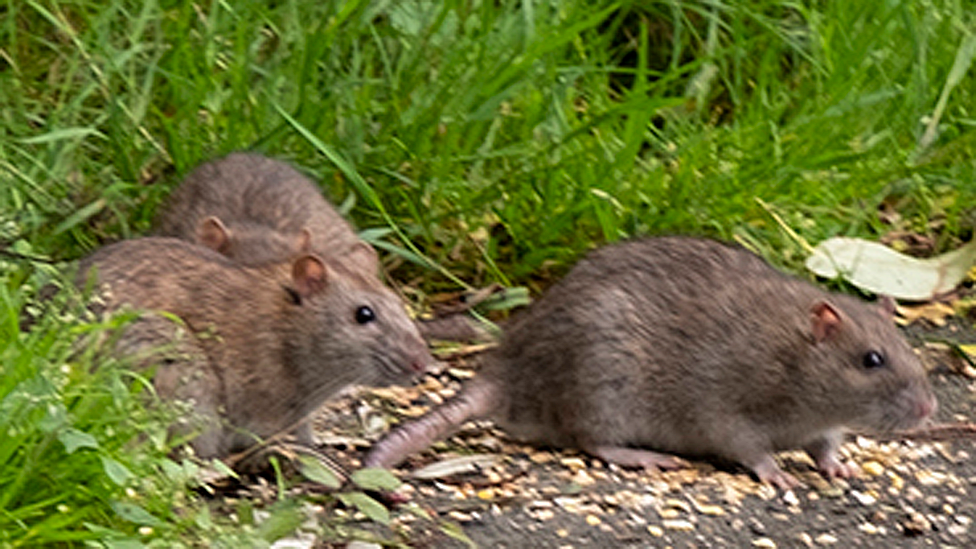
287,254,434,386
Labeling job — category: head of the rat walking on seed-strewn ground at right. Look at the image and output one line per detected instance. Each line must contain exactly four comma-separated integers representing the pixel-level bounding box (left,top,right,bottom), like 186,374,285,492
809,295,936,432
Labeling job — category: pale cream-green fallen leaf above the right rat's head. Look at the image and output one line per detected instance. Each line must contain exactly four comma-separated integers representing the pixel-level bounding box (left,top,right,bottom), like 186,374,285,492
806,237,976,301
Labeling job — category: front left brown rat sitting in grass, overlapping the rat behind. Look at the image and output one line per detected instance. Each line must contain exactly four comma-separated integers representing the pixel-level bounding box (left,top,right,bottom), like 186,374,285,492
78,237,433,458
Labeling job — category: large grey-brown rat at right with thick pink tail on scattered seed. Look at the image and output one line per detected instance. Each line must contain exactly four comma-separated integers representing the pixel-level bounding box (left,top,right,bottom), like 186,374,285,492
364,237,937,489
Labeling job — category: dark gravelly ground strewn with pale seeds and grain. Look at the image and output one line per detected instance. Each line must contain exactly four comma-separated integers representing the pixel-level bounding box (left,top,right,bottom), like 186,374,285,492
286,314,976,548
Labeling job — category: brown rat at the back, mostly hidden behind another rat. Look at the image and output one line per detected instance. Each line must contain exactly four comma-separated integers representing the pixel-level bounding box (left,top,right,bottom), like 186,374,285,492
153,152,379,274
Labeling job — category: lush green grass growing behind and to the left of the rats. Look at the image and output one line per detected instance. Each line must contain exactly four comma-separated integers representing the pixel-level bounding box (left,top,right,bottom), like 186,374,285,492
0,0,976,543
